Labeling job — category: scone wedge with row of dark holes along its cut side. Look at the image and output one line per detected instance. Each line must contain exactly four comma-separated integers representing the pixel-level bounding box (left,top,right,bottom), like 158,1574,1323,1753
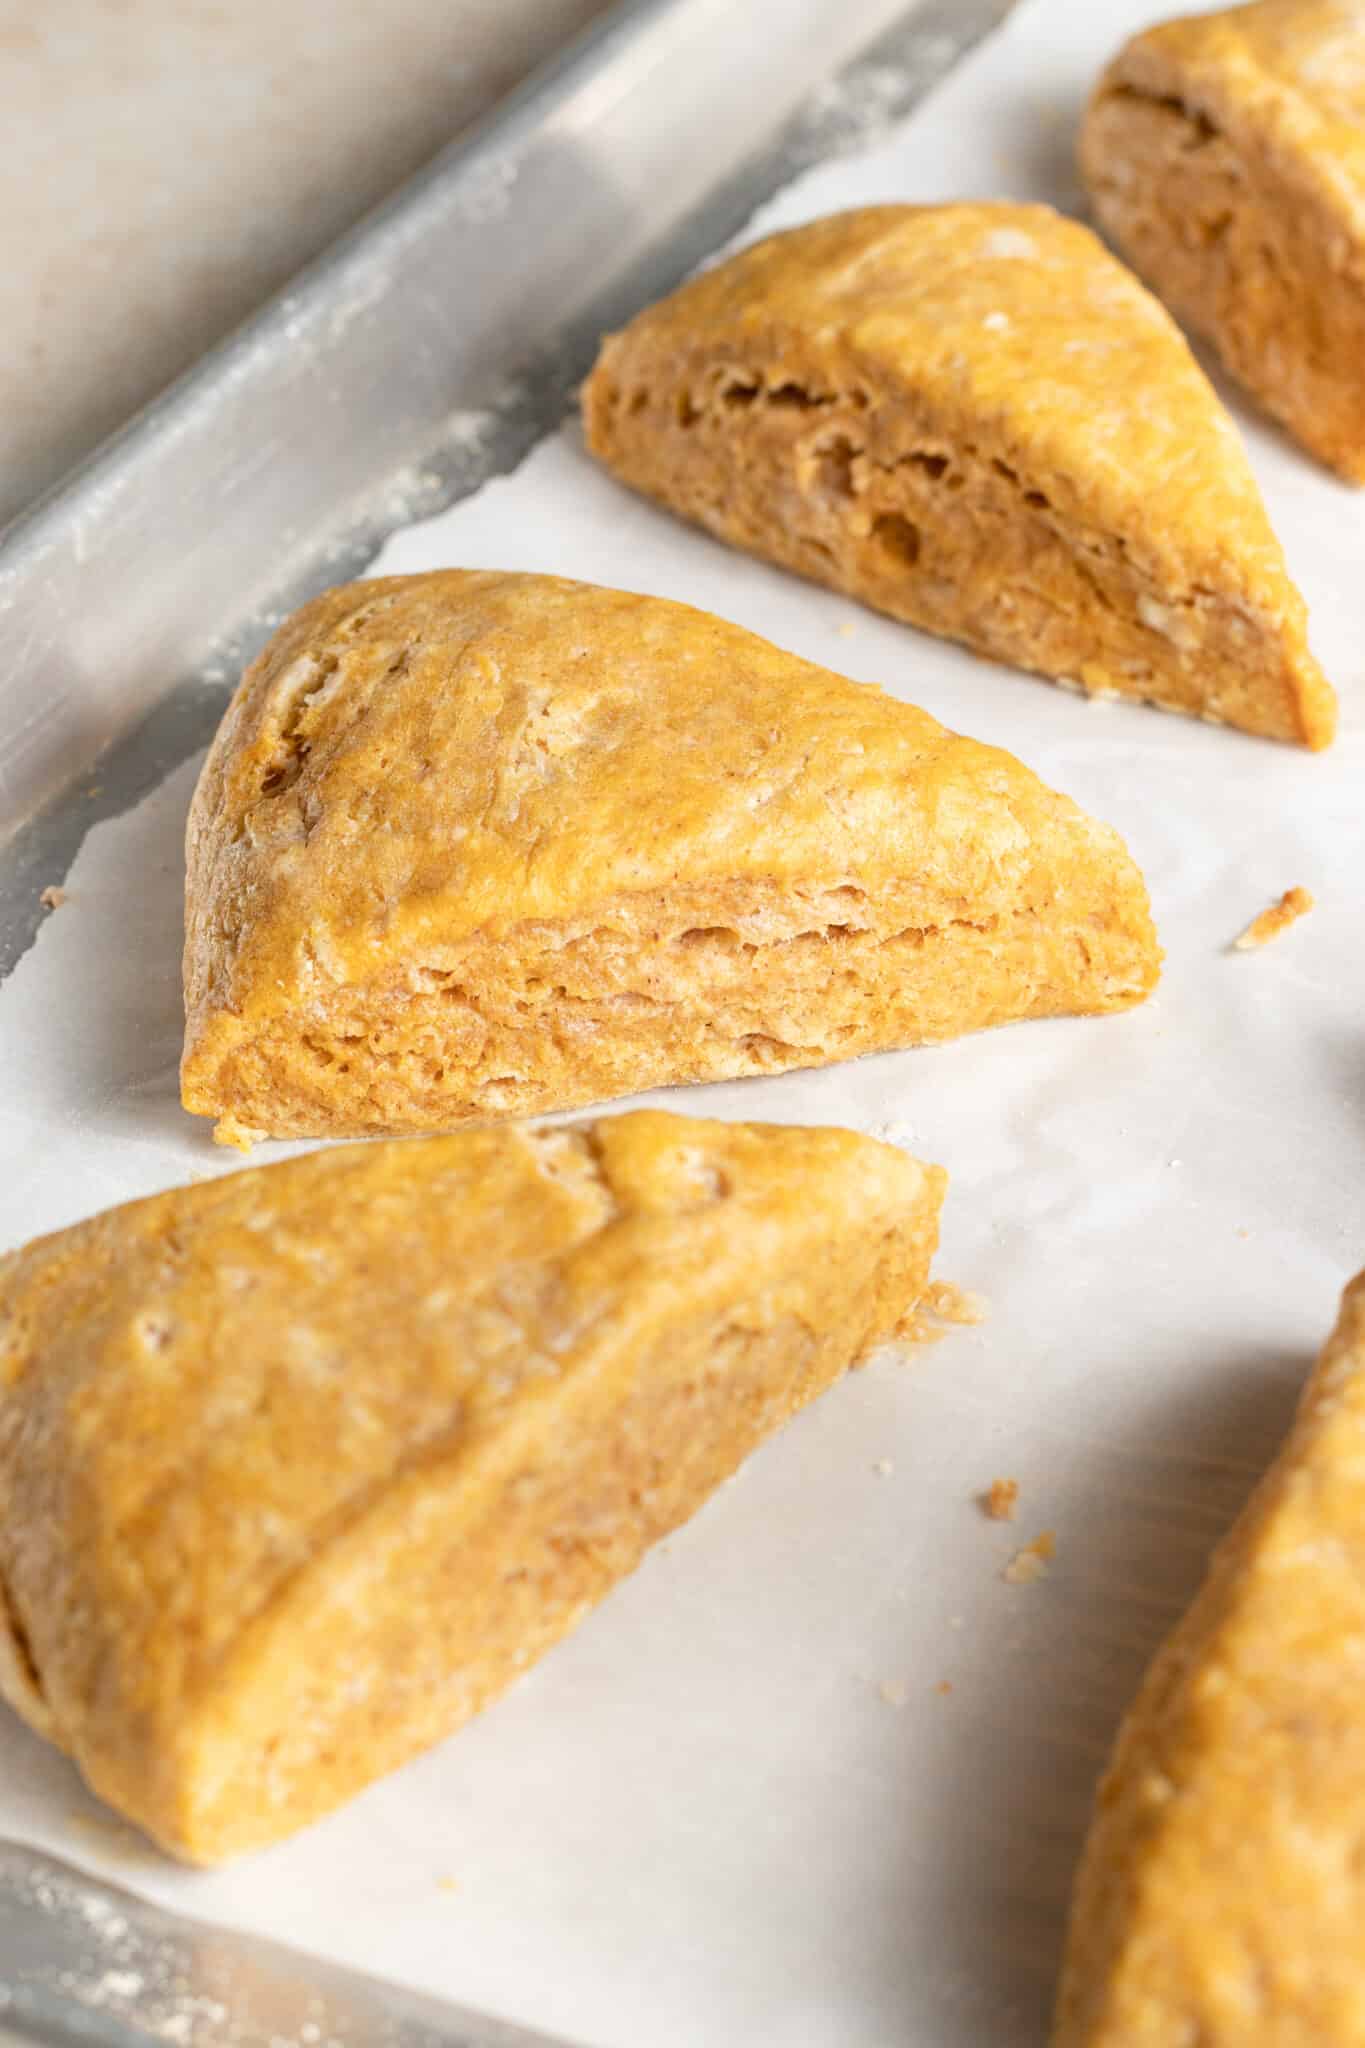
583,205,1336,748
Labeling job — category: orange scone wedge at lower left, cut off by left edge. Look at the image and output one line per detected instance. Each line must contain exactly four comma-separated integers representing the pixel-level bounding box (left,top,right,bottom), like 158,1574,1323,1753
0,1112,945,1864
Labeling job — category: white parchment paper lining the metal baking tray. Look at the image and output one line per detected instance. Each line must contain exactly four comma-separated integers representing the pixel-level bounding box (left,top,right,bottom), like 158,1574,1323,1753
0,0,1365,2048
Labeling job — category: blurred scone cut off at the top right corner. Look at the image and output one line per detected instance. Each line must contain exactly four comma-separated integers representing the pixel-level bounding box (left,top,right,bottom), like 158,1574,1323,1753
1081,0,1365,483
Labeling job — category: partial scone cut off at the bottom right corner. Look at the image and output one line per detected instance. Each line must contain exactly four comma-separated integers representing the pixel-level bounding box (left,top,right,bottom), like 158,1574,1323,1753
1054,1274,1365,2048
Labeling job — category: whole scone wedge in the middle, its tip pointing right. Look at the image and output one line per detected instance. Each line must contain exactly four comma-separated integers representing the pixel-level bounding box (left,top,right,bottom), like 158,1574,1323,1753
182,571,1158,1139
